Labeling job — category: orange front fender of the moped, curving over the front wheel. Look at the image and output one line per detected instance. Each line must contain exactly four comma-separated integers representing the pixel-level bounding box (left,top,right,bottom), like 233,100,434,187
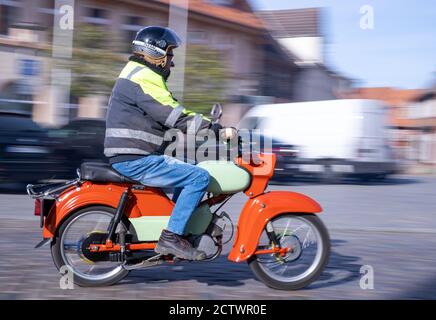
228,191,322,262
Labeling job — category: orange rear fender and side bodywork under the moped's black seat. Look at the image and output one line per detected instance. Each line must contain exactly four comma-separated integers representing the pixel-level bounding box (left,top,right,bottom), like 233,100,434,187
43,181,174,238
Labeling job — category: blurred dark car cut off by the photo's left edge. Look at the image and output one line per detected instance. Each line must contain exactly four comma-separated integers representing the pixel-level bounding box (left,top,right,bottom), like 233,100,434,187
0,112,57,184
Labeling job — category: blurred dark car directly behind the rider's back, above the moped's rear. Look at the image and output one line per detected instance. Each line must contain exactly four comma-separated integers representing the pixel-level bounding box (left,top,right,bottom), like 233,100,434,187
49,119,107,179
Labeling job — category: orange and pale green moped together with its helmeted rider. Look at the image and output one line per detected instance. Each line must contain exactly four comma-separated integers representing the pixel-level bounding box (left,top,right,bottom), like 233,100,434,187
27,27,330,290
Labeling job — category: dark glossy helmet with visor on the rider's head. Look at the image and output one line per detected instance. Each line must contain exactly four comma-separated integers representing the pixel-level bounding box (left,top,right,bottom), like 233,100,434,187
132,27,182,67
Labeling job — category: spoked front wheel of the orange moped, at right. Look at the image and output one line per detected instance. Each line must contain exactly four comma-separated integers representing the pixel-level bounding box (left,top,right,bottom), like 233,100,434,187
248,213,330,290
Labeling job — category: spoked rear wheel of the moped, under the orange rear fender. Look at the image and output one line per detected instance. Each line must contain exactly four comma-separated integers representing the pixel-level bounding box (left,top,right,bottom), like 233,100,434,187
51,206,129,287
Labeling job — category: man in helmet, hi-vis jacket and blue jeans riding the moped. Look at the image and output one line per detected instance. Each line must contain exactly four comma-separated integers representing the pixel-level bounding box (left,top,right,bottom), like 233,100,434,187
104,26,236,260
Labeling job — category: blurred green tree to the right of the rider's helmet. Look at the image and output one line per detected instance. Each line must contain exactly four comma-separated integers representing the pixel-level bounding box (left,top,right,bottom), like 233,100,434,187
183,45,230,114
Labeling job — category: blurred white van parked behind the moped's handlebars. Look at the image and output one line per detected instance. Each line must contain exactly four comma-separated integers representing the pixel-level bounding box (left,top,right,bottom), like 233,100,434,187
239,99,397,178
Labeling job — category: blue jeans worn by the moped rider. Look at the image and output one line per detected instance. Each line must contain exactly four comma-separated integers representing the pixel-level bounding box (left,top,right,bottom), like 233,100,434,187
112,155,209,235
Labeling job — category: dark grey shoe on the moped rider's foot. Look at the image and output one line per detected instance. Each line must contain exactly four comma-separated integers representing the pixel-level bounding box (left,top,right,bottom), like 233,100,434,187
154,230,206,260
